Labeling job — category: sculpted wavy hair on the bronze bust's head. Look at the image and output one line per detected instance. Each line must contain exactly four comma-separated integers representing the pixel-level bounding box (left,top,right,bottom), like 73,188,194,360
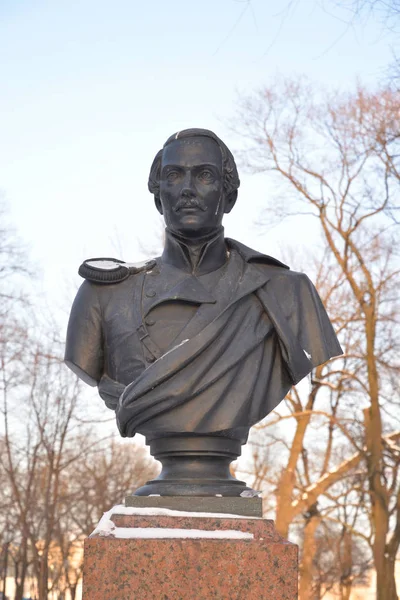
148,129,240,199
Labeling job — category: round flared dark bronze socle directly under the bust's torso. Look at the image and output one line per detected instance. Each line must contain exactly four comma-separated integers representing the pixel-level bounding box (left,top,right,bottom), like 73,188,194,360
134,435,257,496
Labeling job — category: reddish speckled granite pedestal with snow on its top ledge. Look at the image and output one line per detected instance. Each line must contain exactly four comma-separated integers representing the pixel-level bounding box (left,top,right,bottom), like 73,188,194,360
83,507,298,600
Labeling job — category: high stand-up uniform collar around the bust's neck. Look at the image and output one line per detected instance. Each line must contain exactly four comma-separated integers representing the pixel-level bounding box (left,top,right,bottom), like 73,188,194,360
161,227,228,276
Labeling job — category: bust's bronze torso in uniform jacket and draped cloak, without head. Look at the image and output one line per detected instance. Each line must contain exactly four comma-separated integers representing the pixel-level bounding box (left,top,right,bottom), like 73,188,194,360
65,233,342,441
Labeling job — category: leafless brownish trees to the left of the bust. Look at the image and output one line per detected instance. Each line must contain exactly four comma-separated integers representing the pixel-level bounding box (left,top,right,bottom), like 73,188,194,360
0,202,157,600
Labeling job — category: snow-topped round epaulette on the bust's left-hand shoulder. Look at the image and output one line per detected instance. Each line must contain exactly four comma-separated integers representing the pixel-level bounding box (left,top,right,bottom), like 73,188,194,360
78,258,156,283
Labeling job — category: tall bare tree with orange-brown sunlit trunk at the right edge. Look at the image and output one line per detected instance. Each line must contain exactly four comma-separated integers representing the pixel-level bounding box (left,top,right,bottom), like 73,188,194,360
233,81,400,600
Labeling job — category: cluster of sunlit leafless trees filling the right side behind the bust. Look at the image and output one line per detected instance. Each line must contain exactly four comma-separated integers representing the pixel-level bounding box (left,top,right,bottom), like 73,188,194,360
235,80,400,600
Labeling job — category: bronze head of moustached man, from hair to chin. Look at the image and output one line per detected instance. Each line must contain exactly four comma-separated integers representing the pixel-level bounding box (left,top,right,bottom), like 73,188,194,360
148,129,240,237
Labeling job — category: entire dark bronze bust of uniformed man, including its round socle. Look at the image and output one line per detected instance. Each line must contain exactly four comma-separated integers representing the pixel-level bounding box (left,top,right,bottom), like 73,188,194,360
65,129,342,496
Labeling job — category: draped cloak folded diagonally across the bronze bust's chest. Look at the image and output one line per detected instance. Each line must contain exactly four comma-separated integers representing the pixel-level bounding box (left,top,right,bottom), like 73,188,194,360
66,239,342,442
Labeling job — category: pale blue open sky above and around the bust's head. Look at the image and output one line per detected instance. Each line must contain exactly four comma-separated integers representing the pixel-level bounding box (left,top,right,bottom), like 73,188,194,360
0,0,394,318
